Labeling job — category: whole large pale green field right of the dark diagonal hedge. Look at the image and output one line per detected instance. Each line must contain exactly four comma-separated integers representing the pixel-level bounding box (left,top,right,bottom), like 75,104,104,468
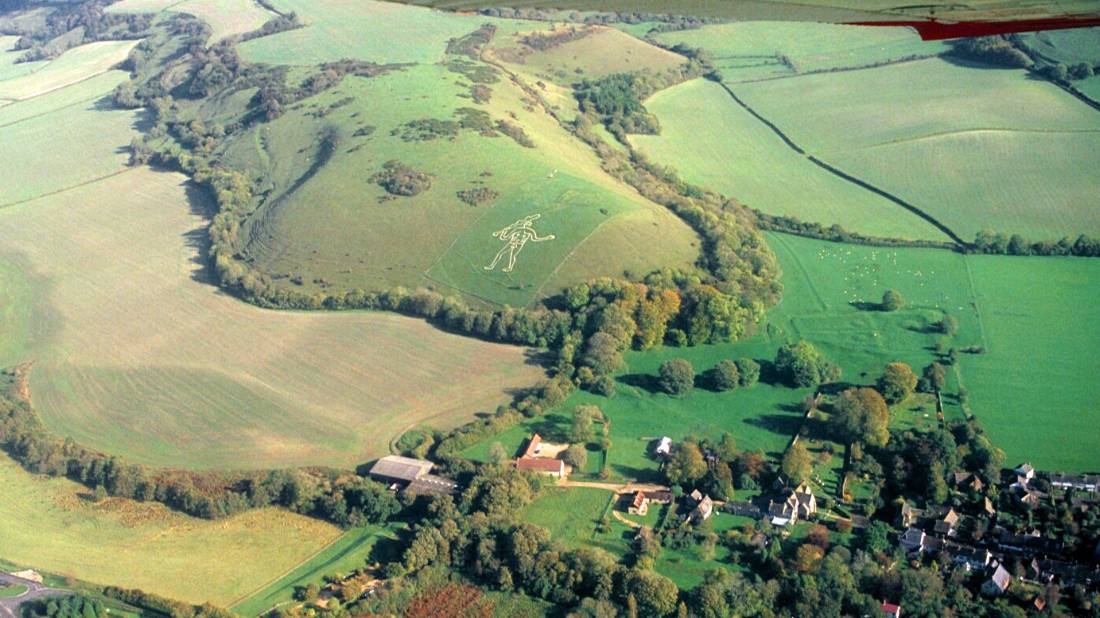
736,59,1100,238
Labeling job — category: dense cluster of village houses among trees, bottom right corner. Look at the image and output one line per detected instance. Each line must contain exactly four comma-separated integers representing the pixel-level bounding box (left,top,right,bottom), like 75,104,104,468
898,463,1100,596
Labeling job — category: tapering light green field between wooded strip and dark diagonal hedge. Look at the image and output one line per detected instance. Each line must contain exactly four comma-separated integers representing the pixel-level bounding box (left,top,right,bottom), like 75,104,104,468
630,79,946,240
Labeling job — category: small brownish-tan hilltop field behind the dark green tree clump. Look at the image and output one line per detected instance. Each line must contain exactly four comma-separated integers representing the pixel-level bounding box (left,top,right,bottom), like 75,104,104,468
493,26,686,85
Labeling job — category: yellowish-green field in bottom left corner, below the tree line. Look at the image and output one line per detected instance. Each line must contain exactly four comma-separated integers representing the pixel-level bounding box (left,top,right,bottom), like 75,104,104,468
0,455,340,606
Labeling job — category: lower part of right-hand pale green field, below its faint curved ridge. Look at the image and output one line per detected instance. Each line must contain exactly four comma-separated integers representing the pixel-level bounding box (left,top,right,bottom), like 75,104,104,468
832,130,1100,240
